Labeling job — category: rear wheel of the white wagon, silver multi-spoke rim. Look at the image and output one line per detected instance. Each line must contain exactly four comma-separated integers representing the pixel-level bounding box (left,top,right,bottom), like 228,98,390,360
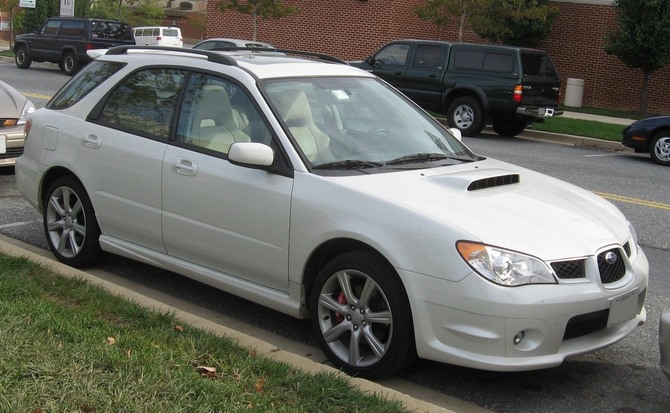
43,175,103,268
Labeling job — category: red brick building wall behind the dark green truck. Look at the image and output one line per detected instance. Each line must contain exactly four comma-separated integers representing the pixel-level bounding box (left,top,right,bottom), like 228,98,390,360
205,0,670,114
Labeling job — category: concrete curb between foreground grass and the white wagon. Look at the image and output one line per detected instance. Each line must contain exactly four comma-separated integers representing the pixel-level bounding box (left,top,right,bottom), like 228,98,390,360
0,234,460,413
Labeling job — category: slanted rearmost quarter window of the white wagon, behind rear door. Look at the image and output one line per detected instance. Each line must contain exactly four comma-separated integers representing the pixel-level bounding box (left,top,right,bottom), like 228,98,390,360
46,60,124,110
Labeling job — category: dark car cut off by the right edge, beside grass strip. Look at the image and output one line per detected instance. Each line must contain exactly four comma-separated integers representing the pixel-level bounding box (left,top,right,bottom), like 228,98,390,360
621,116,670,166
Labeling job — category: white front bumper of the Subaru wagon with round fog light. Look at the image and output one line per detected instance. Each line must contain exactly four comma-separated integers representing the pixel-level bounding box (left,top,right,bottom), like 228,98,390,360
400,243,649,371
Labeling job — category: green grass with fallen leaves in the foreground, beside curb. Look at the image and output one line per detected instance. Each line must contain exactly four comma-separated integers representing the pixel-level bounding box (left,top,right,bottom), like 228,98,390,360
0,254,406,412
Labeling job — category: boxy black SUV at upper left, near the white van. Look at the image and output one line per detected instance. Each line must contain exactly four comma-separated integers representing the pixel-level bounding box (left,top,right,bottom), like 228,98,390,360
14,17,135,76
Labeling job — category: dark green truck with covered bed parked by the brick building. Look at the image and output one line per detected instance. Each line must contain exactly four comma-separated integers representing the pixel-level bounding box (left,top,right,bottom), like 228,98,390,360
350,40,563,136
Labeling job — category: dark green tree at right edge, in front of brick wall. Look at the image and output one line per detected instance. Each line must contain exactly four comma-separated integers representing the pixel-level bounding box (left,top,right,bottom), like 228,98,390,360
605,0,670,113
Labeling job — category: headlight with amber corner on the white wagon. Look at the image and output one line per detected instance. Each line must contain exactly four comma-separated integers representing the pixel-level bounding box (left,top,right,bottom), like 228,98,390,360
456,241,556,287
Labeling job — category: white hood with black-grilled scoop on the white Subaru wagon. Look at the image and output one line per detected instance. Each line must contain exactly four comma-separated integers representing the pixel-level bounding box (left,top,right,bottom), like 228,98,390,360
334,159,630,260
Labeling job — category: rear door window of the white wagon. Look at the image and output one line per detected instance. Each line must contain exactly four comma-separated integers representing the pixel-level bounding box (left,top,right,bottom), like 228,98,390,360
100,69,186,139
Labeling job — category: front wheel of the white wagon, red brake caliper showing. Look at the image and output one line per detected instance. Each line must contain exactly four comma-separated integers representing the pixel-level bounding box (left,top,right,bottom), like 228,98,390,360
310,251,416,378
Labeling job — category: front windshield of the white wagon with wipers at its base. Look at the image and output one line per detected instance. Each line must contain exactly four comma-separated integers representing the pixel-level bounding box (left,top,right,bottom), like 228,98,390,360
261,77,478,173
